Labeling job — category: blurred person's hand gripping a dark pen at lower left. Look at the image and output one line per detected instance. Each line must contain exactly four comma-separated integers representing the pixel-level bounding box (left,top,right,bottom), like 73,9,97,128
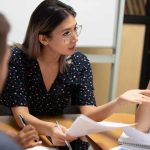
14,125,42,148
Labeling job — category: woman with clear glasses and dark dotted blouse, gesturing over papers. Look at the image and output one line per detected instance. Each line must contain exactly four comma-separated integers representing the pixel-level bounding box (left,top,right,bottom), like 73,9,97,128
0,0,149,150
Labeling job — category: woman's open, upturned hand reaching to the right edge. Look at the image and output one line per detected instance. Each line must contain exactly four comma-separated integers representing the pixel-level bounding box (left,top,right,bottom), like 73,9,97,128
118,89,150,104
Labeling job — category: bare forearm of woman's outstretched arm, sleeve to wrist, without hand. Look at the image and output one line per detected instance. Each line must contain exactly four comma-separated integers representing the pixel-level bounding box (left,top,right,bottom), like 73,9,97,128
81,98,124,121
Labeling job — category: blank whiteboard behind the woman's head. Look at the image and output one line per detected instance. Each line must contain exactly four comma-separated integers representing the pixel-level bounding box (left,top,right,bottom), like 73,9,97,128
0,0,118,47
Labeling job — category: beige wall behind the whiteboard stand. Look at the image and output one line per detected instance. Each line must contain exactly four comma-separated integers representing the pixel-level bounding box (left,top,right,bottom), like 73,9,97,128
80,24,145,113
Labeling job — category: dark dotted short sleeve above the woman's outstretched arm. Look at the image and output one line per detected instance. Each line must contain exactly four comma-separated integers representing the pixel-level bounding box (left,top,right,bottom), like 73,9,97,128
72,54,96,105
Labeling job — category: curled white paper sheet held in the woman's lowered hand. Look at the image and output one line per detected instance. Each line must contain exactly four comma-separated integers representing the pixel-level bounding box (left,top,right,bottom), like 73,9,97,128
67,115,134,137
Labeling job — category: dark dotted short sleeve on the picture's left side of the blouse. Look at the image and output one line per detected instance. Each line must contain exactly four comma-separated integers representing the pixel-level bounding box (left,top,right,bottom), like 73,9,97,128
0,48,27,107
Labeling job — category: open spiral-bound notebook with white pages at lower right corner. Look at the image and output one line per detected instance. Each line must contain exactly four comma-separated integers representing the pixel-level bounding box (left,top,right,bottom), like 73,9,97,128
118,127,150,150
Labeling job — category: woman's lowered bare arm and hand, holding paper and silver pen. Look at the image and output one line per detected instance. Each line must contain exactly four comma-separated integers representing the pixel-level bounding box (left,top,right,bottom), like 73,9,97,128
12,106,74,146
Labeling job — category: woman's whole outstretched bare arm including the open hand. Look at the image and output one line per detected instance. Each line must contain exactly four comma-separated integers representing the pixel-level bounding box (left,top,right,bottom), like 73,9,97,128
80,90,150,121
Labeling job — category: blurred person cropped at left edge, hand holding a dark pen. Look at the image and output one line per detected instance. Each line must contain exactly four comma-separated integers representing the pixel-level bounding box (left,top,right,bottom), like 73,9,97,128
0,14,41,150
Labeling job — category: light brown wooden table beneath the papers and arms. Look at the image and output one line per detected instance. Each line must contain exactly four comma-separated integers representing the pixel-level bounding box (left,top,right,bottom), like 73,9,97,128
0,114,134,150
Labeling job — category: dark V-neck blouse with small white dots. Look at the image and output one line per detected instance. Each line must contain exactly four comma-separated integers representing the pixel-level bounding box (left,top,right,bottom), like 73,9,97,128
0,48,96,115
